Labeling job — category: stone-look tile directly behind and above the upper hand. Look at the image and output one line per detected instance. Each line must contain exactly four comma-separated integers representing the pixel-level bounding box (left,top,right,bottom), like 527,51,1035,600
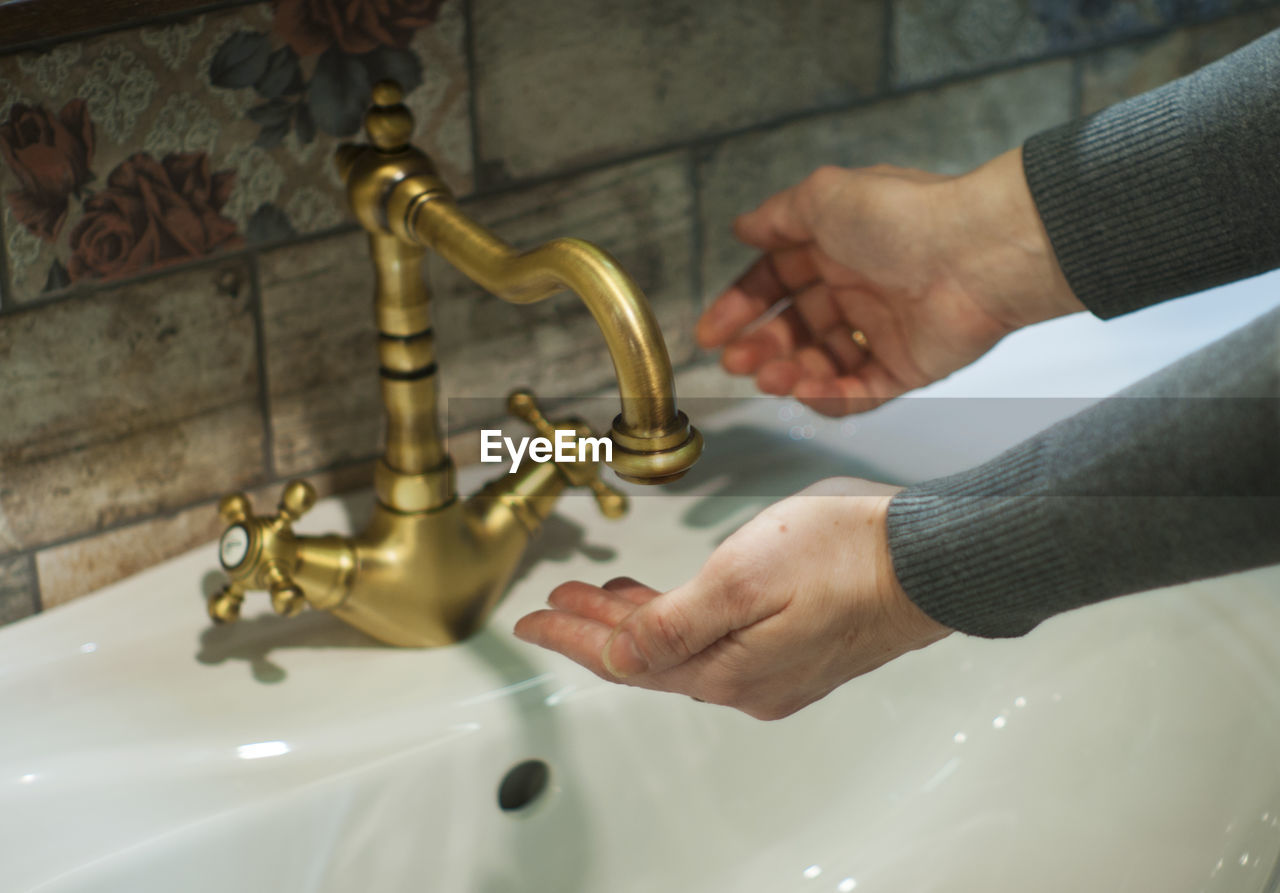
699,61,1071,299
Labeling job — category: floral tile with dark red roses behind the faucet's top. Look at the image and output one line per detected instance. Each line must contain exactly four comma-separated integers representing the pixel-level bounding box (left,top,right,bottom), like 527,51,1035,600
0,0,471,304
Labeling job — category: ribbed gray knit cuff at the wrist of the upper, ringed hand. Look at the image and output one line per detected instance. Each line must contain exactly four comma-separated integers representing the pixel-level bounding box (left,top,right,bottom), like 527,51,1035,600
1023,82,1249,319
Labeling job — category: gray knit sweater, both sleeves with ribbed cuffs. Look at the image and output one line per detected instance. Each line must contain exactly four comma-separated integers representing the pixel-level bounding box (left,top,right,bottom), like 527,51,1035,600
888,31,1280,636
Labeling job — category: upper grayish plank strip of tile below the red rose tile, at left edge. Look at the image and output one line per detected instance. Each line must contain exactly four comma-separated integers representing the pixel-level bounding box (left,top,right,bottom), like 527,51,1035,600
0,261,257,467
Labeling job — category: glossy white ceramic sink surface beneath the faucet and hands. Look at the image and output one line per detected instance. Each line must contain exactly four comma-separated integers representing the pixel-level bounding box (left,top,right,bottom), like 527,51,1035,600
0,400,1280,893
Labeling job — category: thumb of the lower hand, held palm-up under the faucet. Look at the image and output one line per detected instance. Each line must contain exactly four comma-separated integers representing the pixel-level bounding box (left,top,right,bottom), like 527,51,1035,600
600,578,755,679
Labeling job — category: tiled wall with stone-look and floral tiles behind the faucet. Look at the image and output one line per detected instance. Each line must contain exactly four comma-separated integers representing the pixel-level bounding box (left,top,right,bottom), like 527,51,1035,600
0,0,1280,623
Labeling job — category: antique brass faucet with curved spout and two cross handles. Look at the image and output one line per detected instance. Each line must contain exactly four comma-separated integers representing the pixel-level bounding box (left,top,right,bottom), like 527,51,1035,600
209,81,703,647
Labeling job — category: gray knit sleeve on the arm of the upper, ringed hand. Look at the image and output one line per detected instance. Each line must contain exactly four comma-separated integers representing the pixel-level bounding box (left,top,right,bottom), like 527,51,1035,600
1023,31,1280,319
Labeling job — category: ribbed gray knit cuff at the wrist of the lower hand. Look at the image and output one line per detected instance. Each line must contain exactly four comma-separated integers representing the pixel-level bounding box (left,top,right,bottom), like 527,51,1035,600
888,440,1084,637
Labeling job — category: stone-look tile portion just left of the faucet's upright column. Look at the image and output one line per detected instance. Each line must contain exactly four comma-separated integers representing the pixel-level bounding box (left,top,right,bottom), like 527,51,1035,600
259,230,383,475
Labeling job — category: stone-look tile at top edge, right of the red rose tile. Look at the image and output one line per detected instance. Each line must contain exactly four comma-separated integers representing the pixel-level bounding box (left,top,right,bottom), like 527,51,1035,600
472,0,883,180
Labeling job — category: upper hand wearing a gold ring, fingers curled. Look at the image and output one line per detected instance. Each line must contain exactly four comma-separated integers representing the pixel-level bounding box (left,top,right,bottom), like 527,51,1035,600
698,150,1084,416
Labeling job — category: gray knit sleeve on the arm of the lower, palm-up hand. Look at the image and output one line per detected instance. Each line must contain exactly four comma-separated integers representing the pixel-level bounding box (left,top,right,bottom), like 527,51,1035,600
888,308,1280,637
